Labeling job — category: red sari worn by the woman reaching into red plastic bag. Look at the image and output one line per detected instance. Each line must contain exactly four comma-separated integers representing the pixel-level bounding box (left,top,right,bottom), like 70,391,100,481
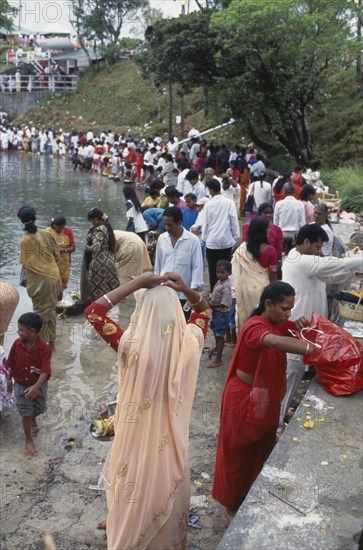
212,316,295,509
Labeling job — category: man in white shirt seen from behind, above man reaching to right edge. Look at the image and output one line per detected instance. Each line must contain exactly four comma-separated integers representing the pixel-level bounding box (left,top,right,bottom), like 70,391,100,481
274,183,305,239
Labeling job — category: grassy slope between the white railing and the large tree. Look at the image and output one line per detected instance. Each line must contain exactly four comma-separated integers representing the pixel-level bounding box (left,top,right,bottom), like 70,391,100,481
16,60,222,137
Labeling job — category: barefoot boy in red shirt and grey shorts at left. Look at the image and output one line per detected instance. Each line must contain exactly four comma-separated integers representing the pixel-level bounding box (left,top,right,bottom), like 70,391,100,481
6,313,52,456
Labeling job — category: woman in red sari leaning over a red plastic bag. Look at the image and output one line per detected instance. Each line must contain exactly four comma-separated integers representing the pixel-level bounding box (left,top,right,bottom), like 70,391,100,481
212,282,314,521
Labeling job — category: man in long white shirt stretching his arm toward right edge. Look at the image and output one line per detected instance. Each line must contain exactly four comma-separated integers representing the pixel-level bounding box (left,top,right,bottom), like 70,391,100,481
279,223,363,433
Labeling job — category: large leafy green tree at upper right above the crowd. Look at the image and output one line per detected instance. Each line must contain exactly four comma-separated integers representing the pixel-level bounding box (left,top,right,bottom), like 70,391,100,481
211,0,359,162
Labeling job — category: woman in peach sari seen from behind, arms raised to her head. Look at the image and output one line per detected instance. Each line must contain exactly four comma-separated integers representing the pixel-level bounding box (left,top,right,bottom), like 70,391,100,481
85,273,210,550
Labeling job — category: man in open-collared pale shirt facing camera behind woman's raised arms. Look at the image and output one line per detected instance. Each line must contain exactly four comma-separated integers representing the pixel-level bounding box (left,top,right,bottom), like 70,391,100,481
154,206,203,305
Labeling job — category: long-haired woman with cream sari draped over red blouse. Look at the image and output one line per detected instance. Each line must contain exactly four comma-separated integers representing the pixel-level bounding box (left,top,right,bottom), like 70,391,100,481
232,217,278,332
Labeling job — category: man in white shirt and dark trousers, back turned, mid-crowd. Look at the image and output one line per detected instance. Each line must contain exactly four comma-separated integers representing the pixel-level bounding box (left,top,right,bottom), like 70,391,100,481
202,179,240,292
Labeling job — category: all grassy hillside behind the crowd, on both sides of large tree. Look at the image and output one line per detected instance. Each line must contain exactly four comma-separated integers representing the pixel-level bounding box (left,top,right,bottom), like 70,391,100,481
15,60,363,168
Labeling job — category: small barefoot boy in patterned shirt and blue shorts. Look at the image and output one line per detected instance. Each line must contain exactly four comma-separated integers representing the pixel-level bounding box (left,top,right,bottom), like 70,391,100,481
208,260,232,368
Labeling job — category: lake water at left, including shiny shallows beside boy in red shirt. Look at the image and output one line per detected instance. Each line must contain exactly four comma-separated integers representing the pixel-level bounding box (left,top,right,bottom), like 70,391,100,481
0,153,130,468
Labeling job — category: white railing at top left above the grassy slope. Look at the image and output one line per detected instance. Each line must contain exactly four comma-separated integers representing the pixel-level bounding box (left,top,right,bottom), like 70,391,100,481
0,73,78,93
